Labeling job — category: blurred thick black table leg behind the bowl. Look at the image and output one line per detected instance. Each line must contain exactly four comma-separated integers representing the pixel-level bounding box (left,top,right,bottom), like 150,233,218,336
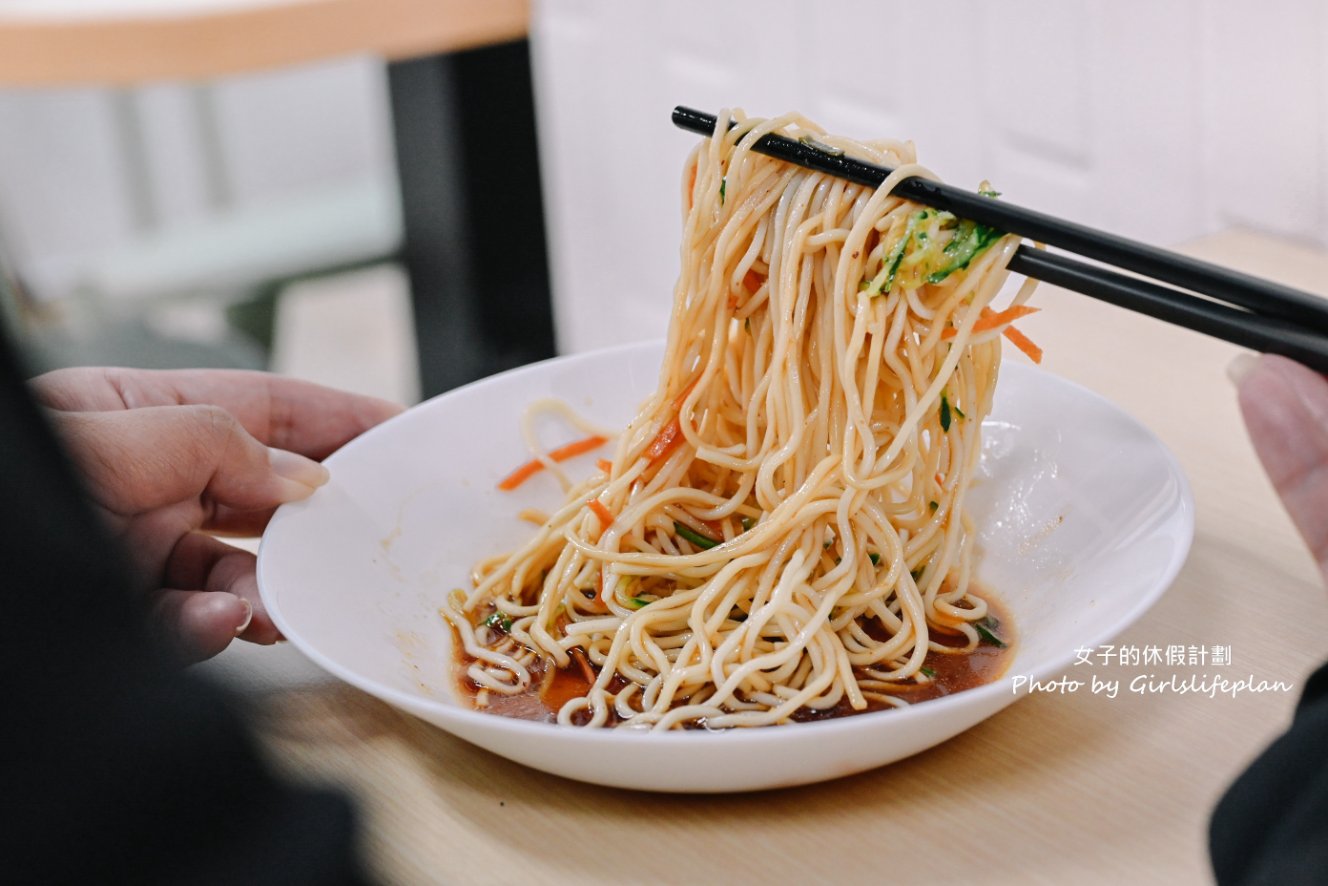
388,41,554,397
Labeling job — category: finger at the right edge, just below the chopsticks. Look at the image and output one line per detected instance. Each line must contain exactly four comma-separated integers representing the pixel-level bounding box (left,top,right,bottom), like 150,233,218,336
1240,355,1328,575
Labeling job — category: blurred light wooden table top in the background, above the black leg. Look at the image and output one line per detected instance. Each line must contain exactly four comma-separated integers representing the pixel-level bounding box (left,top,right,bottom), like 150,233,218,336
0,0,530,86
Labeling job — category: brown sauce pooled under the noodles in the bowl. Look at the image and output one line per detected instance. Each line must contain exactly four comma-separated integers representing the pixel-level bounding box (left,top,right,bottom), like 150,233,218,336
452,588,1017,728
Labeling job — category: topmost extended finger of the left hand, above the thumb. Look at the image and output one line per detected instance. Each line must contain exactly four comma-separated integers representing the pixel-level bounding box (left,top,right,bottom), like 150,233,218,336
32,368,401,458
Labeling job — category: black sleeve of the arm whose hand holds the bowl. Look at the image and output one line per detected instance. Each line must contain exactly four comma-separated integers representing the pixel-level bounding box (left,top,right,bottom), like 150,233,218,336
0,322,363,883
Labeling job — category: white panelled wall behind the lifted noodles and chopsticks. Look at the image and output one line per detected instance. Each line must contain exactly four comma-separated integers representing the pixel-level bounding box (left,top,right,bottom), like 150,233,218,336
534,0,1328,351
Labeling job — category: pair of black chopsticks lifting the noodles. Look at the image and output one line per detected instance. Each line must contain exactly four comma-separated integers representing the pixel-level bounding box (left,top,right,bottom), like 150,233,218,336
673,105,1328,373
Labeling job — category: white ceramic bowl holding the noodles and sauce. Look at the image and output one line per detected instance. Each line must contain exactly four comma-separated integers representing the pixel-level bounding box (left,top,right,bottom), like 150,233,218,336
259,344,1194,792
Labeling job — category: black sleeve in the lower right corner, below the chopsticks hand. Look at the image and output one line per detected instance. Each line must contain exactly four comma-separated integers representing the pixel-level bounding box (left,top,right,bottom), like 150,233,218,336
1208,664,1328,886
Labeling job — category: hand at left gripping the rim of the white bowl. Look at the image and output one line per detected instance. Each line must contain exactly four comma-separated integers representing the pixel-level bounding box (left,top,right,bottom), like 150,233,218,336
31,368,400,662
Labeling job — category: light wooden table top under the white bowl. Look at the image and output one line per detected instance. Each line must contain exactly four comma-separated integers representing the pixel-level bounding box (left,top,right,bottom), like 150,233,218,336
249,232,1328,885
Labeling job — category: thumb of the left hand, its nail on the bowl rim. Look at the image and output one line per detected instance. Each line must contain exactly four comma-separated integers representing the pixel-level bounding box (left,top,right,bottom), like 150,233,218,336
54,405,328,515
